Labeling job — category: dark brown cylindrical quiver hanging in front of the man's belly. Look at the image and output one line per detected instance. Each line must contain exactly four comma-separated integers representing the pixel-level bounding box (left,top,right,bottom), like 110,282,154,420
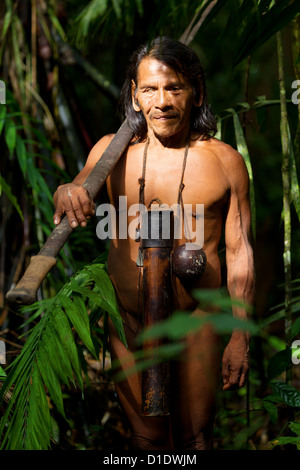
141,208,173,416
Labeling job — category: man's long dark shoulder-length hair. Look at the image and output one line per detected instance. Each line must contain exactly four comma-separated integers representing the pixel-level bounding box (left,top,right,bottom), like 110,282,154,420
120,37,217,142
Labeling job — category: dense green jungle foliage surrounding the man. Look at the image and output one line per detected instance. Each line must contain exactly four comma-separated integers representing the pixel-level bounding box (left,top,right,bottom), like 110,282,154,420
0,0,300,450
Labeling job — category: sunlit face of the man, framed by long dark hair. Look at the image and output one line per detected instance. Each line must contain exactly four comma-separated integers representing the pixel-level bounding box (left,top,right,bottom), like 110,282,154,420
132,57,198,139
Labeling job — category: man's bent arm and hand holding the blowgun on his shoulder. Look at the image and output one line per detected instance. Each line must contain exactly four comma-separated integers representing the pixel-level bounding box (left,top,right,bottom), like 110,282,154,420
53,134,113,228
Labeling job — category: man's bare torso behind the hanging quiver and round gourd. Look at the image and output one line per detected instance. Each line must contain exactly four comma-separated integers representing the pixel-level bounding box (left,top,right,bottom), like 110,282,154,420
107,139,229,314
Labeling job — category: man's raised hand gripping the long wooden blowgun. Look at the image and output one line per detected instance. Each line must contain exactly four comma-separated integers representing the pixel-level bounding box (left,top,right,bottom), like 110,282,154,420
53,183,95,228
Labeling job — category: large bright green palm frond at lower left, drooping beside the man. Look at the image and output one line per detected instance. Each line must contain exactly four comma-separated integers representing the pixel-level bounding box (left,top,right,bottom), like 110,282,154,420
0,260,125,450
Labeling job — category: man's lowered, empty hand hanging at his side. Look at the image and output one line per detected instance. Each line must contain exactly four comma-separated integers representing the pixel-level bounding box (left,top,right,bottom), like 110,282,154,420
222,334,249,390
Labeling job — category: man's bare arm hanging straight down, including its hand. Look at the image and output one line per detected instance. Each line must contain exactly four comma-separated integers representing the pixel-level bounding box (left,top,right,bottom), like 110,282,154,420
222,151,254,390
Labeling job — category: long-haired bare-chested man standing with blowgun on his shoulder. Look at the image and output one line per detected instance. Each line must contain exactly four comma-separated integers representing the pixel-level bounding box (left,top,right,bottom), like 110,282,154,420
54,38,254,450
